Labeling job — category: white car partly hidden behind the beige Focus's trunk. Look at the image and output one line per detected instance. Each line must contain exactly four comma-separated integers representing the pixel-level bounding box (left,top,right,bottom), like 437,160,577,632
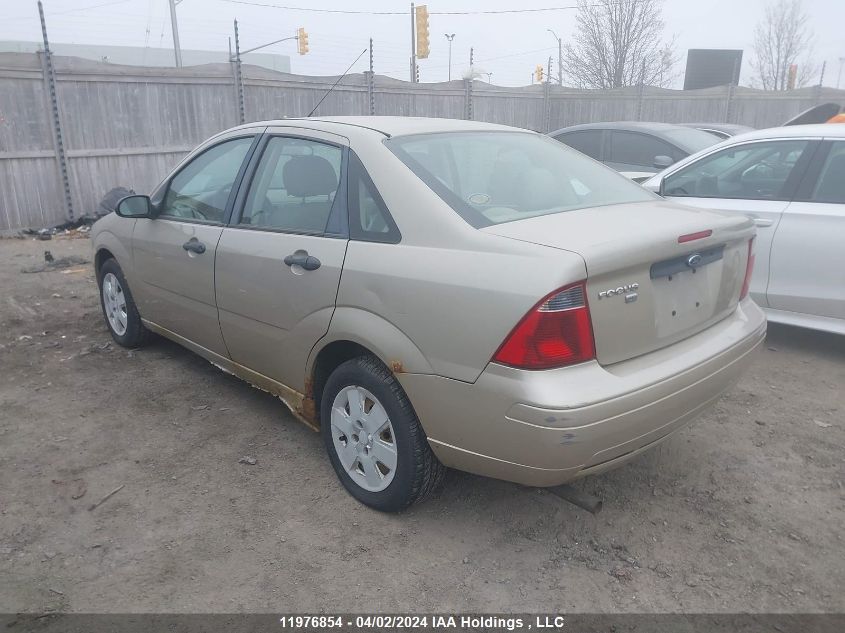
644,125,845,334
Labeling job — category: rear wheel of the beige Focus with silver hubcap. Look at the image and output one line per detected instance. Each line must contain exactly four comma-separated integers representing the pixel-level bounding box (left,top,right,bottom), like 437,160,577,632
320,356,446,512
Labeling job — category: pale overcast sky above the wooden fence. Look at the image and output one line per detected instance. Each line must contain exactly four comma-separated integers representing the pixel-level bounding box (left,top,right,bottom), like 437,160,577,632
0,0,845,87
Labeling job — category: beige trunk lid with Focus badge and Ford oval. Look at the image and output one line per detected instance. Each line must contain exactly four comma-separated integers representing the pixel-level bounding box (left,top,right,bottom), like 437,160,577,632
481,201,754,365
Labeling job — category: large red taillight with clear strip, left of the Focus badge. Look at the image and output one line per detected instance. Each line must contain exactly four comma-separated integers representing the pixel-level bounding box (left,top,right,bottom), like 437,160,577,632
493,282,596,369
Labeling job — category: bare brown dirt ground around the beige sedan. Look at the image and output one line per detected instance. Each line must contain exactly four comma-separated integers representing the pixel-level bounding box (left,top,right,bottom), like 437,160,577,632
0,233,845,612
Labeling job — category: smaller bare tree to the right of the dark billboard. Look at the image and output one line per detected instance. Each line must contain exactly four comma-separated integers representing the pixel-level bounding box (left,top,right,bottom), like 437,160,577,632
751,0,816,90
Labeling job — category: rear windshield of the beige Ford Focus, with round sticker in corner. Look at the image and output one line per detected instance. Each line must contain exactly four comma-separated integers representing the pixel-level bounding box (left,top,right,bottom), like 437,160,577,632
385,132,657,228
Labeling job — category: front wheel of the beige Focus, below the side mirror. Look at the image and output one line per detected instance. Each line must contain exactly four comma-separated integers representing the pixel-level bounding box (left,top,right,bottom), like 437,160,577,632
97,259,152,348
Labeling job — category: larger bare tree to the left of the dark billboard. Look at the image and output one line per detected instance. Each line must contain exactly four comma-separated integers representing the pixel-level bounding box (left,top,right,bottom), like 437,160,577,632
563,0,677,88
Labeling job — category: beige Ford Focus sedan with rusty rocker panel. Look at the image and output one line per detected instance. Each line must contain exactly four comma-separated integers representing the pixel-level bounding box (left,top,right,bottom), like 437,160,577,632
92,117,765,511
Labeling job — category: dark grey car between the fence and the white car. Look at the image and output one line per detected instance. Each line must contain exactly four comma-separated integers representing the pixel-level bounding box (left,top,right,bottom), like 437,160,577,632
549,121,719,175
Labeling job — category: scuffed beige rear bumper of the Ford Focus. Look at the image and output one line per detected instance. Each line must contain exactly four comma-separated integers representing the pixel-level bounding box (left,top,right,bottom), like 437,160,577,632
398,299,766,486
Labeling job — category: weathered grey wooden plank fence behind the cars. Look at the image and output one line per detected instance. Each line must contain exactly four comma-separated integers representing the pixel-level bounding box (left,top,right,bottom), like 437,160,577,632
0,53,845,232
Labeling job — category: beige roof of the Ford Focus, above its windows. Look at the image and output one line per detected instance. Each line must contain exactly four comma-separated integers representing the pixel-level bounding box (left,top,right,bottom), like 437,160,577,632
231,116,530,136
